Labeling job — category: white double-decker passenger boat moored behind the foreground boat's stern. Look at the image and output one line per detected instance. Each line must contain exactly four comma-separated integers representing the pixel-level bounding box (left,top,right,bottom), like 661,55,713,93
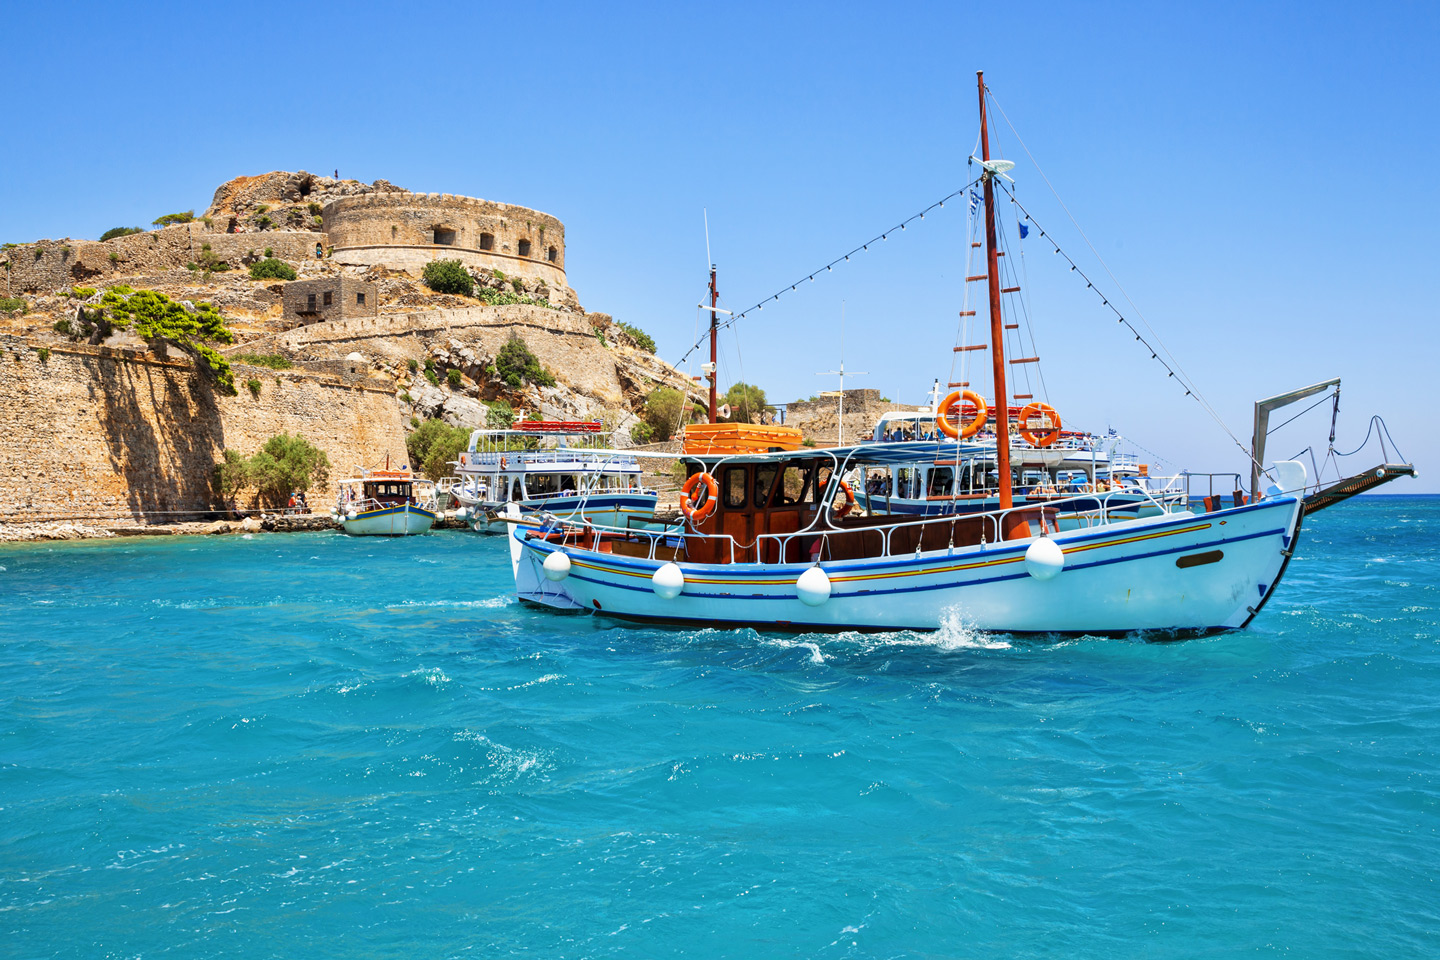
449,420,657,533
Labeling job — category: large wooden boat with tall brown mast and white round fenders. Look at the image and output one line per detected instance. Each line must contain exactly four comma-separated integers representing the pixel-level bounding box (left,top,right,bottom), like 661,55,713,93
507,71,1306,635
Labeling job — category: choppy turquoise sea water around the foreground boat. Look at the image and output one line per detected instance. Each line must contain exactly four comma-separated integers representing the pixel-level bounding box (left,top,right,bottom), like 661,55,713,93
0,497,1440,957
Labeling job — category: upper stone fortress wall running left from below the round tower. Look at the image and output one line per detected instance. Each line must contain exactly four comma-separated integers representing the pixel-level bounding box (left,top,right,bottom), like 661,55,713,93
0,220,325,295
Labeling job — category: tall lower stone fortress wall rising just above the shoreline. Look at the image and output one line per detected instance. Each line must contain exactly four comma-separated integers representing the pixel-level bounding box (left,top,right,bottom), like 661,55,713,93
0,337,405,520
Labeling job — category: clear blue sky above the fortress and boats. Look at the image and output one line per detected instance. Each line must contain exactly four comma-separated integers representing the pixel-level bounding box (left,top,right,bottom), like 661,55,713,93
0,3,1440,492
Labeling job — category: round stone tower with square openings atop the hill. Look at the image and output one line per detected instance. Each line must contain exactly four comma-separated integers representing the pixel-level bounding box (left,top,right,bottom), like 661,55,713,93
321,193,569,291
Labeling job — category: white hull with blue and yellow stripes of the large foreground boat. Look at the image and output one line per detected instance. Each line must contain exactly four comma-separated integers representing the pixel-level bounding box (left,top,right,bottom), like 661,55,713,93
511,497,1302,635
